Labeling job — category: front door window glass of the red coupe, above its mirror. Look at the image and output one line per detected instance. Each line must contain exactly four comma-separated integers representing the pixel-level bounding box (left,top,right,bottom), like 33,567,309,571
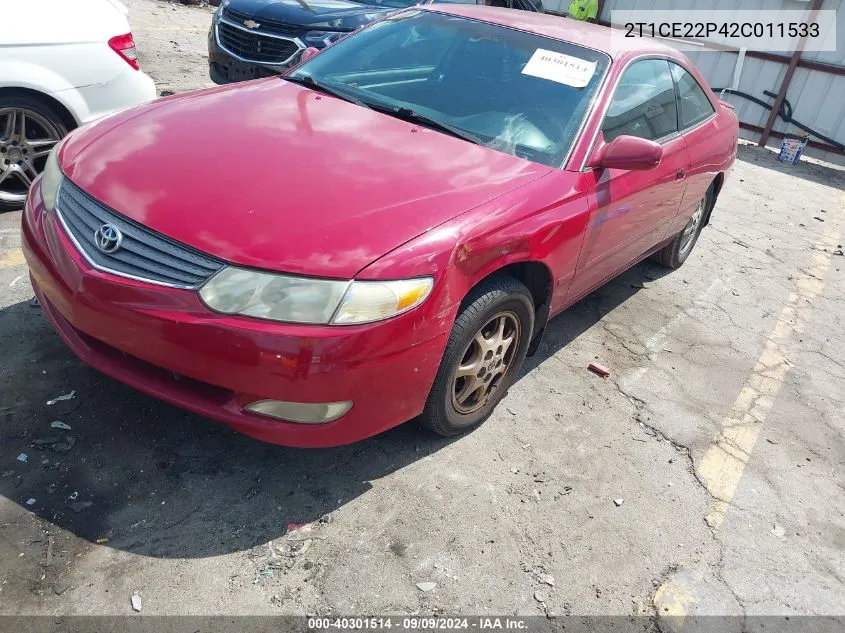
601,59,678,143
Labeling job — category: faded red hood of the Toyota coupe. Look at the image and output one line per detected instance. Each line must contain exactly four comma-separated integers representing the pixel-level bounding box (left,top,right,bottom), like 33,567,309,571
59,78,551,278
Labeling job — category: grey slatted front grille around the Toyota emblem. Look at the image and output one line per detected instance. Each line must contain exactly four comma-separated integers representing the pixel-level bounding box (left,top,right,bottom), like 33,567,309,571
56,178,224,288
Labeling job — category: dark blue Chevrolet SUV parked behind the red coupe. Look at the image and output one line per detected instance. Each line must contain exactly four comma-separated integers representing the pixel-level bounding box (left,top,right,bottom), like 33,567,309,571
208,0,542,84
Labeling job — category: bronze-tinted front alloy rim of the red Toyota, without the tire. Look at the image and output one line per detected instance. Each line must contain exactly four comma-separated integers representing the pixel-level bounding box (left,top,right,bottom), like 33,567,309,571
452,310,521,414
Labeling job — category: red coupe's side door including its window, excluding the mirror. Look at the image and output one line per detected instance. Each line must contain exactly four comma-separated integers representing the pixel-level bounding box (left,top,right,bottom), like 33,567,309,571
570,58,689,296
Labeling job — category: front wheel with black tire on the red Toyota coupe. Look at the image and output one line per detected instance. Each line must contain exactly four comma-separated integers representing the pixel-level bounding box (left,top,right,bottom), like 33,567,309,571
419,275,534,437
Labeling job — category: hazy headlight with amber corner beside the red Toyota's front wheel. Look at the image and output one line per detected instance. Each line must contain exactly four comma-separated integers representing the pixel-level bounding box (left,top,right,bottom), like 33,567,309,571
199,267,434,325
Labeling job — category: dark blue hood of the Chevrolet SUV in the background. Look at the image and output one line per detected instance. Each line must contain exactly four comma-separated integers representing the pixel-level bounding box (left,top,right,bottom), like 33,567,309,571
224,0,396,31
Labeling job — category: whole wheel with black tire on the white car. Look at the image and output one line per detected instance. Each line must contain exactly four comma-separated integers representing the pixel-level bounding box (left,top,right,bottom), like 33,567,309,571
0,94,68,212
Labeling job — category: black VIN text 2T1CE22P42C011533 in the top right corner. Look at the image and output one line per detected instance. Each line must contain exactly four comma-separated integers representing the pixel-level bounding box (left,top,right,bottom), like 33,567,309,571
625,22,821,39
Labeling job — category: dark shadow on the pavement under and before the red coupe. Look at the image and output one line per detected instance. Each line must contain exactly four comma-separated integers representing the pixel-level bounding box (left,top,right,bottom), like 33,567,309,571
0,256,663,558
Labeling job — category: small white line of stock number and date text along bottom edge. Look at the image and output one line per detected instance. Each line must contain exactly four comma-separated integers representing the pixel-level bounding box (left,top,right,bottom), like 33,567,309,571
308,616,528,631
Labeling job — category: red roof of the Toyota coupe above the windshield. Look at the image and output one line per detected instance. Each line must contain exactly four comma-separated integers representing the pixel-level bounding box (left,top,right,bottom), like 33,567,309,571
417,4,686,61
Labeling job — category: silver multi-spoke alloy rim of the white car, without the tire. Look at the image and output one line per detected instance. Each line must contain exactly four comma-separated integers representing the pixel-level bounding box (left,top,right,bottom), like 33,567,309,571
0,107,62,203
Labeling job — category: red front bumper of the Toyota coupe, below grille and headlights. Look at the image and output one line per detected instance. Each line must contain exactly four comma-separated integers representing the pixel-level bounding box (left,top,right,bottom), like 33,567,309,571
22,181,452,447
